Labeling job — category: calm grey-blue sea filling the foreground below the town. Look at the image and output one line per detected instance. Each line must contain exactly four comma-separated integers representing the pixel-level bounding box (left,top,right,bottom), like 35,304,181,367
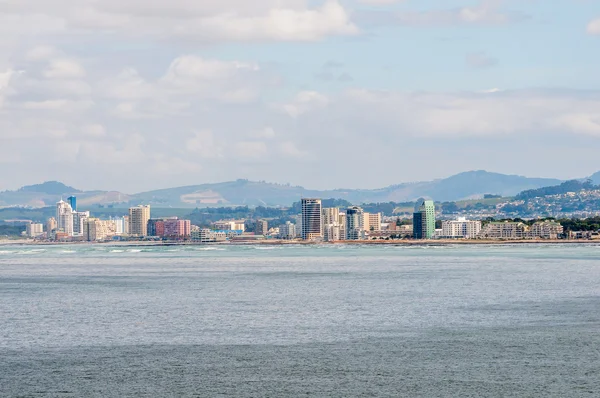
0,245,600,397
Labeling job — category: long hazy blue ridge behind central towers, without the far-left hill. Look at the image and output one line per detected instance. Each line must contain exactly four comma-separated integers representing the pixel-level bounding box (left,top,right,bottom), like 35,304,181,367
132,171,562,207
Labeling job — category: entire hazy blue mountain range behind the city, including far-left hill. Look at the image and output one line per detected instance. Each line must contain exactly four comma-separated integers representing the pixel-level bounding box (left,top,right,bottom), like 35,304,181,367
0,170,600,209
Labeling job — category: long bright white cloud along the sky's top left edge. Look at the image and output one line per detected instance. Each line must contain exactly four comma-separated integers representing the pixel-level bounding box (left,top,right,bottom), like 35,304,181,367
0,0,358,42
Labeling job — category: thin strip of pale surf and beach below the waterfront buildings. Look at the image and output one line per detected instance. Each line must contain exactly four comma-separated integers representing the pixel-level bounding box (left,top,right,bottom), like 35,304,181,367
0,239,600,247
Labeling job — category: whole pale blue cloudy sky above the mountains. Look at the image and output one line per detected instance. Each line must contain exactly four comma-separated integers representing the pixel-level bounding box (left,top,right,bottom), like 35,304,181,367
0,0,600,193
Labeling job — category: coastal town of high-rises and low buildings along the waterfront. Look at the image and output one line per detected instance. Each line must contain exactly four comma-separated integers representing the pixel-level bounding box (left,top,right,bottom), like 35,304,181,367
11,196,600,244
